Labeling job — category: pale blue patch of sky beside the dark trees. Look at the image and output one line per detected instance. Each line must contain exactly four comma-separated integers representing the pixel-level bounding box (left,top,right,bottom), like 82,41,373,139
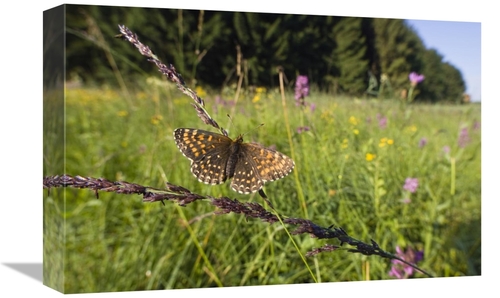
407,20,481,101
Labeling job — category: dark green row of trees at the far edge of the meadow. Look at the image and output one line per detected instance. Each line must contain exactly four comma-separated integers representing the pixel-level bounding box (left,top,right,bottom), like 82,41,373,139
66,5,465,102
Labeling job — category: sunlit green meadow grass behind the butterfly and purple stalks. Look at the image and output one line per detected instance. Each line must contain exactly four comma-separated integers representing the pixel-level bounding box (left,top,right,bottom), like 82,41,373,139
44,82,481,293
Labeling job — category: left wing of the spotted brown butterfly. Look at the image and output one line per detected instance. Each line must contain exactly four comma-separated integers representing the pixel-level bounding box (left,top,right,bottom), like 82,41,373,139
174,128,233,184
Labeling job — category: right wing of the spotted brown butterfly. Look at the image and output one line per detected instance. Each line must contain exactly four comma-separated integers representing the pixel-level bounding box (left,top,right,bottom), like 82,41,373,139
231,143,295,194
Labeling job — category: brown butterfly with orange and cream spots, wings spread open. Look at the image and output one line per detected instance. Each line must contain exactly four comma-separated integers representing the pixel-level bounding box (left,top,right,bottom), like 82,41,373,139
174,128,295,194
